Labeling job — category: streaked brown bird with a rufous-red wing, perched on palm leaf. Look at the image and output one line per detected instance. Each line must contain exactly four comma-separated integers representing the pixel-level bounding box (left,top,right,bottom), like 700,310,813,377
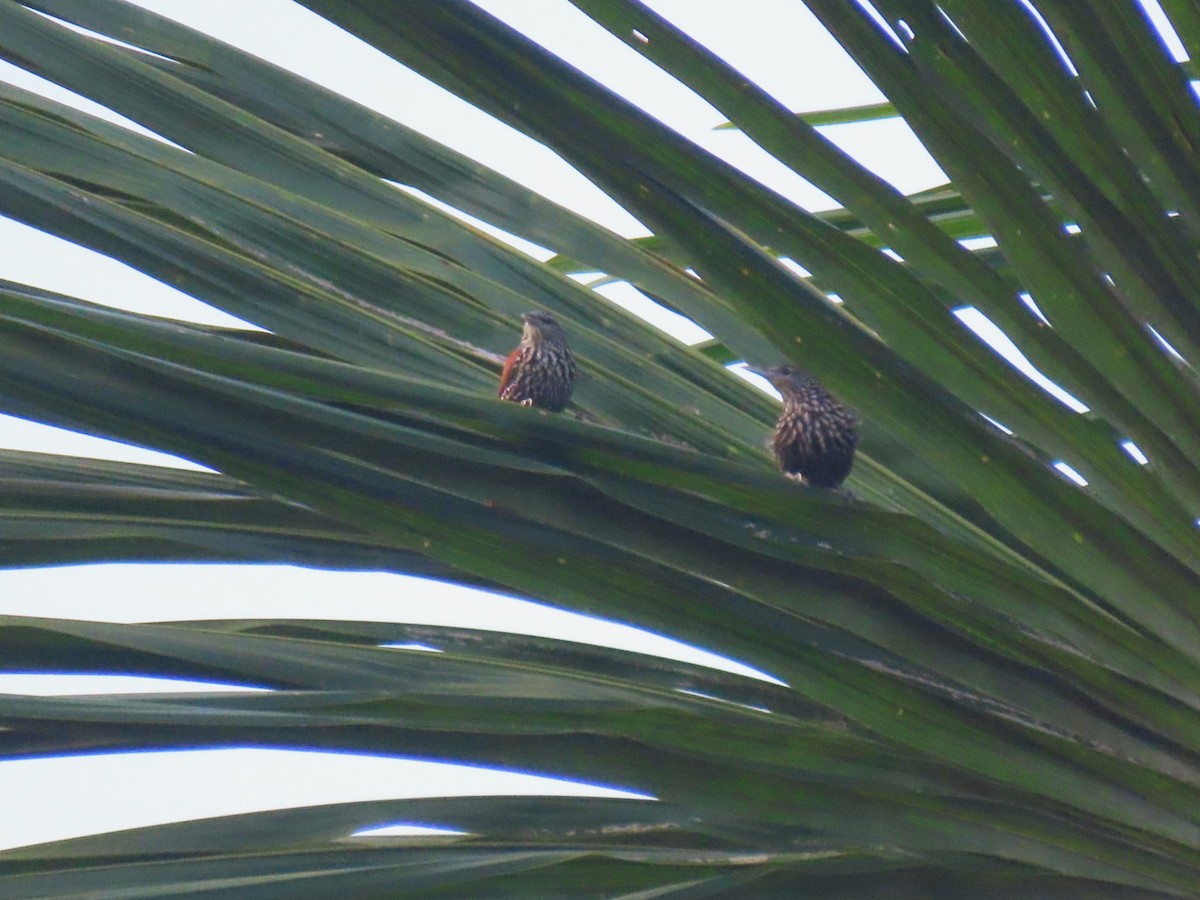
499,311,576,413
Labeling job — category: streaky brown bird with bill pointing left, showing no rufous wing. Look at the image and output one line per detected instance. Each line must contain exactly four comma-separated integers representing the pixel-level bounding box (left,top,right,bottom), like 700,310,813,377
748,365,858,488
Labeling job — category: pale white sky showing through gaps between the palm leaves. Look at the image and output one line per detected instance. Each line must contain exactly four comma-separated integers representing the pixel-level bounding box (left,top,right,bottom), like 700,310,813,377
0,0,1161,848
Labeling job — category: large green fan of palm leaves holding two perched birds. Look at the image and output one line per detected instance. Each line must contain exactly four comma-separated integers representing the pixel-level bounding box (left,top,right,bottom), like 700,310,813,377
0,0,1200,898
